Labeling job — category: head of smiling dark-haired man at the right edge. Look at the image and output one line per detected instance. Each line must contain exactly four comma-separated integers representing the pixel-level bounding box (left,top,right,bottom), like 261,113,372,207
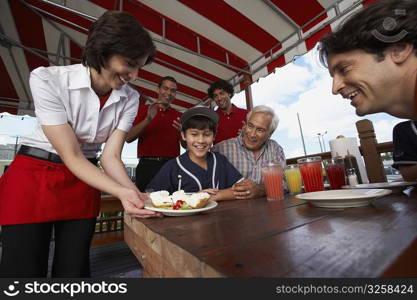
319,0,417,120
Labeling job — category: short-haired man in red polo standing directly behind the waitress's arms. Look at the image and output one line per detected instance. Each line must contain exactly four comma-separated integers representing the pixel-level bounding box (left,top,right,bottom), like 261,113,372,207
126,76,181,192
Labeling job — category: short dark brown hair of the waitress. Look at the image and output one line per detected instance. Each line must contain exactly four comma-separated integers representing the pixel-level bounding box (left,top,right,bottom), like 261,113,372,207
81,11,156,73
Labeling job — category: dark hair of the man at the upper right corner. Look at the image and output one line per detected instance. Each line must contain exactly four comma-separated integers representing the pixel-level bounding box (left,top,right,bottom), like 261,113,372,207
319,0,417,67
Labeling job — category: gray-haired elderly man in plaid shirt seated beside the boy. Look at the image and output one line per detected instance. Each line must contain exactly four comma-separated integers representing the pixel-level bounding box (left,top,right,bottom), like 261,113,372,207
213,105,285,199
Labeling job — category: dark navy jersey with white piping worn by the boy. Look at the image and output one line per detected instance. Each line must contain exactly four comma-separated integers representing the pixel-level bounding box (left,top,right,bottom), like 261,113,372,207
147,151,242,193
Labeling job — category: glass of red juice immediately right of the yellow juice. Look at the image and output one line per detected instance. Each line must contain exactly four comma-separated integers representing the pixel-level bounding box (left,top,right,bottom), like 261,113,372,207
297,156,324,193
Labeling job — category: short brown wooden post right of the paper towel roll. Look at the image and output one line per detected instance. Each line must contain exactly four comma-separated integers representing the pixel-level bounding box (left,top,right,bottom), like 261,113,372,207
356,119,387,183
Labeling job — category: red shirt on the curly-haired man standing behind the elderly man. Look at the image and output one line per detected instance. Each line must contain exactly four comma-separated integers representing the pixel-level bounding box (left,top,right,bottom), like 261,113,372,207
214,104,248,144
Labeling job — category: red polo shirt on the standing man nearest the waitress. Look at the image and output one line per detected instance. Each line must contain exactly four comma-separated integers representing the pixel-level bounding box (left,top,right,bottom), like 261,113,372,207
133,105,181,157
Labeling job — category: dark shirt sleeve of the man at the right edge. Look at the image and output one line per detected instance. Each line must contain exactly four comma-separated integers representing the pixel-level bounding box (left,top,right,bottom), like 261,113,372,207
392,121,417,169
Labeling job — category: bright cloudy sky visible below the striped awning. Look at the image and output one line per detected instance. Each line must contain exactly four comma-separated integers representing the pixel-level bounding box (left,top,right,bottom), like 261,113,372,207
0,48,403,164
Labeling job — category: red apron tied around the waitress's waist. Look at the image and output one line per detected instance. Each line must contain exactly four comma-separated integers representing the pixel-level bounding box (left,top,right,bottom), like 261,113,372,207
0,155,100,225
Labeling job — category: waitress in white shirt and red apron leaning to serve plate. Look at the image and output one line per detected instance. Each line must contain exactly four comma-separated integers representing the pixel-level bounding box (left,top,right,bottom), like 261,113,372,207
0,11,158,277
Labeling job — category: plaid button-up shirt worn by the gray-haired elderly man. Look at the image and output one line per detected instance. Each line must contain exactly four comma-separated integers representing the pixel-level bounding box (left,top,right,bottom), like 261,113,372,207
212,134,285,183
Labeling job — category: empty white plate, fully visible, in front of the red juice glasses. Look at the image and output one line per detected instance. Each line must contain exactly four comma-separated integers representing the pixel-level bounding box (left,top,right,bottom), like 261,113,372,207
295,189,392,208
